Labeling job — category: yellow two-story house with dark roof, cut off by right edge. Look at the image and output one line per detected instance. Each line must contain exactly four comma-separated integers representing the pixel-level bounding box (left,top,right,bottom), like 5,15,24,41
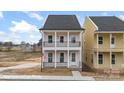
83,16,124,70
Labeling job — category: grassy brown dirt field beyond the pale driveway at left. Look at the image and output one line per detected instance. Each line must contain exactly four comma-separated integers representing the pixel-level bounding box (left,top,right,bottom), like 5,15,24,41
0,51,41,67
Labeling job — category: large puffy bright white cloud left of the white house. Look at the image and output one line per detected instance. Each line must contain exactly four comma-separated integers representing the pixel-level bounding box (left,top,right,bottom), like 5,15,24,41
9,20,38,33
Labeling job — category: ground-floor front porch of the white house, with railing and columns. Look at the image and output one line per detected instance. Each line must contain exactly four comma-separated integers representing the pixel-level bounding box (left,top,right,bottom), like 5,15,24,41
42,50,82,69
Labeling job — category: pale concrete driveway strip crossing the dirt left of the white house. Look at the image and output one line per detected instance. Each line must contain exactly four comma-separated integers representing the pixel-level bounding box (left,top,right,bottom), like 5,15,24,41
0,63,40,72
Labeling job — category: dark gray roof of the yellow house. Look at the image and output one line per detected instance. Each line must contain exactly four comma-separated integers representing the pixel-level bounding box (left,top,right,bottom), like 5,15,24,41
89,16,124,31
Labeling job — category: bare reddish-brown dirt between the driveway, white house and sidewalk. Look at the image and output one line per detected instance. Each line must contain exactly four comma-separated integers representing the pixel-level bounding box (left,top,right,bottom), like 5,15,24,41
1,67,72,76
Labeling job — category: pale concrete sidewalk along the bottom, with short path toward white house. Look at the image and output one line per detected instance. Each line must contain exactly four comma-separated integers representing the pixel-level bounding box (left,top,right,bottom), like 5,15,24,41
0,71,95,81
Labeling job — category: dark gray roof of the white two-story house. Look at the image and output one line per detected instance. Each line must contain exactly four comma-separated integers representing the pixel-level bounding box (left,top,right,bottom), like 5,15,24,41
41,15,82,30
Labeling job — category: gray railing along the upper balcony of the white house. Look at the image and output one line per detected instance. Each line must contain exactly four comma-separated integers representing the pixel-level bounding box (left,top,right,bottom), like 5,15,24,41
43,41,81,47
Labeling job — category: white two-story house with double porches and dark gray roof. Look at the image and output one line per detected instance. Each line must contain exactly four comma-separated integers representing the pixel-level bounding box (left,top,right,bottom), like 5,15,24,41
40,15,83,69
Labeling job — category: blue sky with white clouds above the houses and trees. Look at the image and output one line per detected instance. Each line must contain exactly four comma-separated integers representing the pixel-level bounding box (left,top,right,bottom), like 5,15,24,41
0,11,124,44
